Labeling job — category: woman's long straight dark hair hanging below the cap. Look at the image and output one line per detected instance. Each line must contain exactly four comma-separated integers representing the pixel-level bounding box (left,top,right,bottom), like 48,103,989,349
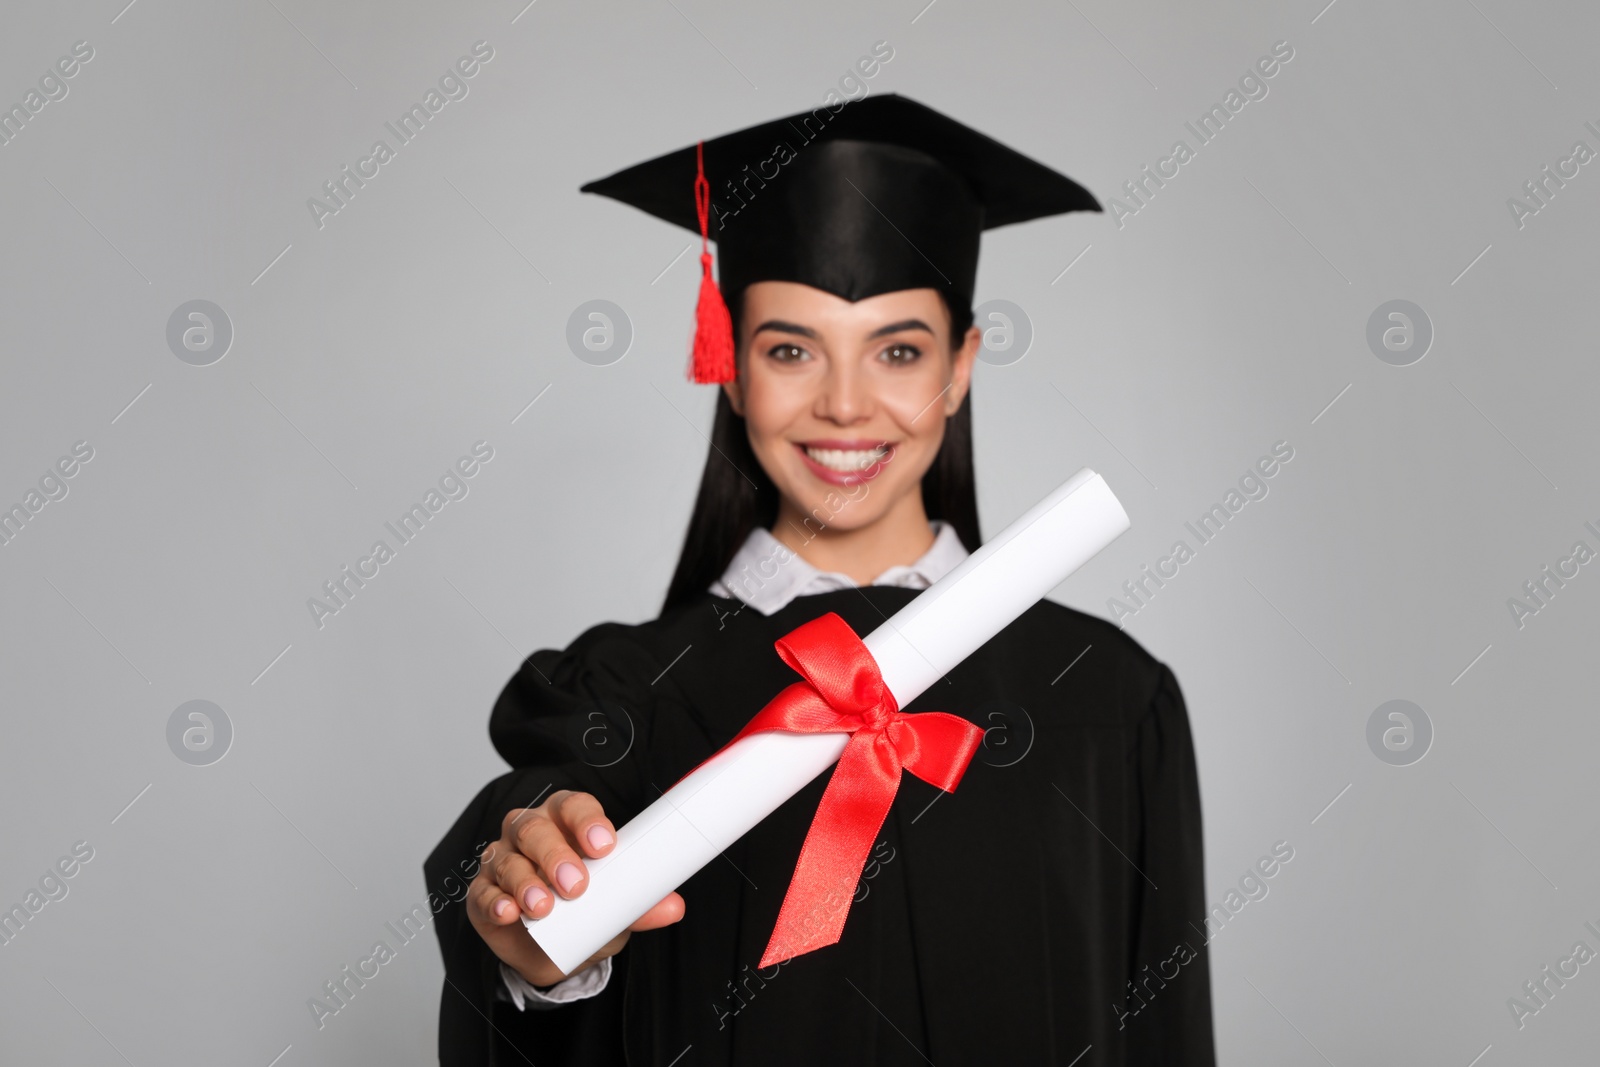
661,296,982,613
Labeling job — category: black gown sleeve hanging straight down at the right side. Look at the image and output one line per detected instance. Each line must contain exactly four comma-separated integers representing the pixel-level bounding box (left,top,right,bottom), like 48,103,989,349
1126,664,1216,1067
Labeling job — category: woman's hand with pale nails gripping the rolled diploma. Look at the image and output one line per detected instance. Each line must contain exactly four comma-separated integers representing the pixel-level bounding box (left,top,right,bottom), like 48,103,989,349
467,789,683,985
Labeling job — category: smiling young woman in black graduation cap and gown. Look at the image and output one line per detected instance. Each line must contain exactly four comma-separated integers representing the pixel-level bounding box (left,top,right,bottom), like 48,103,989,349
426,96,1213,1067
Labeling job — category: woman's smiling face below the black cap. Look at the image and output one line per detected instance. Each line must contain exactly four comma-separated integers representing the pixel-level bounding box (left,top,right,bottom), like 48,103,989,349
723,282,981,543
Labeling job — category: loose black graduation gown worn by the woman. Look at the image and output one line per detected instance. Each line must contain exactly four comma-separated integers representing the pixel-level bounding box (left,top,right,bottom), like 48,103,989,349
424,585,1214,1067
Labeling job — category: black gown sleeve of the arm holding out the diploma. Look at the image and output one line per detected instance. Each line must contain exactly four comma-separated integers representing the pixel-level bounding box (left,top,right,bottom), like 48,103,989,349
422,624,661,1067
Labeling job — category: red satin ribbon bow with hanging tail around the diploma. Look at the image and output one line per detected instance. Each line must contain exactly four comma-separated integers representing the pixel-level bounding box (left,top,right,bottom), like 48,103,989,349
681,611,984,968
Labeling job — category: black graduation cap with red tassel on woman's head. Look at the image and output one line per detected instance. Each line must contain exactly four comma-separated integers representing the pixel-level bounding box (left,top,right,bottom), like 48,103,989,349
582,93,1101,382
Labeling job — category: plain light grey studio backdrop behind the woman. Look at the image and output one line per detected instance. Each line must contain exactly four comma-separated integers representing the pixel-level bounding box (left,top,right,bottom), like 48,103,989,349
0,0,1600,1067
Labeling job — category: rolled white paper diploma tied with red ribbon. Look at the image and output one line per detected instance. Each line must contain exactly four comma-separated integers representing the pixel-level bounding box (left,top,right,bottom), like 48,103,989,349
523,467,1130,974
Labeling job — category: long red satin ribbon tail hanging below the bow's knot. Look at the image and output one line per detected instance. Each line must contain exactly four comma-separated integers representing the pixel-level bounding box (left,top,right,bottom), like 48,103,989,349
758,731,899,968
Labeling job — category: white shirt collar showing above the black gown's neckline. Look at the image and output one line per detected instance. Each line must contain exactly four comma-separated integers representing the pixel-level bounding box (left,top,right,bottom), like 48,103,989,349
710,520,968,614
